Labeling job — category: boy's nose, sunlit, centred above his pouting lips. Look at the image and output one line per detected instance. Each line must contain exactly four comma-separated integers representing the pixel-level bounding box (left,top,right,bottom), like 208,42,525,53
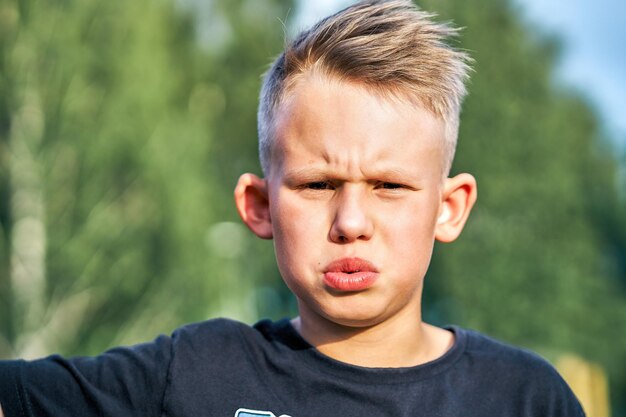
330,185,374,243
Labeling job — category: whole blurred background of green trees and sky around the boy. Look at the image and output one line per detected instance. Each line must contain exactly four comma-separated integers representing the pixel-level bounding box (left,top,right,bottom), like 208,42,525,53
0,0,626,417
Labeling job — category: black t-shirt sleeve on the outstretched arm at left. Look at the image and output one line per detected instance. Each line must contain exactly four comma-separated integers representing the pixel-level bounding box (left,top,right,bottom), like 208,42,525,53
0,336,172,417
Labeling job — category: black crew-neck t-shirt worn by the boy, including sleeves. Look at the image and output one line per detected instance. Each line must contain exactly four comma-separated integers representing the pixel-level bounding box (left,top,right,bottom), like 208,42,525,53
0,319,584,417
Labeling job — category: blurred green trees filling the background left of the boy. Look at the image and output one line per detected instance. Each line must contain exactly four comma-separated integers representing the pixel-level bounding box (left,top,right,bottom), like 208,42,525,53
0,0,289,357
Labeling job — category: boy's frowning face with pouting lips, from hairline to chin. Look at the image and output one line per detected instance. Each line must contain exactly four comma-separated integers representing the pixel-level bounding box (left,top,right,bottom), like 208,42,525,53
235,76,472,327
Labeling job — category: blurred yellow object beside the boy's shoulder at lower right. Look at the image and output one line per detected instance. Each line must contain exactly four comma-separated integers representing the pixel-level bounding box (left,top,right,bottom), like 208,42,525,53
556,354,611,417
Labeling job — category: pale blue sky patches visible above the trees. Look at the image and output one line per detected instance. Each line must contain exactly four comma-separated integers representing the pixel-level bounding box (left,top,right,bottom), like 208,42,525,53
297,0,626,152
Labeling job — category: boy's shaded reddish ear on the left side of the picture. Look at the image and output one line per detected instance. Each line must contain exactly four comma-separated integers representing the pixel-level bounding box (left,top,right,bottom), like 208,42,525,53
235,174,272,239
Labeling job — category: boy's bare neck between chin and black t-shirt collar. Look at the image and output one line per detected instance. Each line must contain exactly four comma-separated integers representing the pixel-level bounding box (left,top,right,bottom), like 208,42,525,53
292,308,454,368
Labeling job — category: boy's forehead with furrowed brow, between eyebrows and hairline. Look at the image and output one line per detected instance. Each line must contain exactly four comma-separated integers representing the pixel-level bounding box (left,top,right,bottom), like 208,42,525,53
271,74,445,179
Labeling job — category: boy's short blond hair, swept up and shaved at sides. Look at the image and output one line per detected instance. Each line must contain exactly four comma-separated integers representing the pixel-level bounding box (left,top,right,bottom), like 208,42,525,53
257,0,471,175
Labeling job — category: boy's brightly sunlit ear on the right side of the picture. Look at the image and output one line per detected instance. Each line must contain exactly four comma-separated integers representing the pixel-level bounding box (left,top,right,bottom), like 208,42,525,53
435,174,478,243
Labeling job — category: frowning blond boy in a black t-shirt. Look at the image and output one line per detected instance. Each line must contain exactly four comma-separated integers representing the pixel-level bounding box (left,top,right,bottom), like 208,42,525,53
0,0,584,417
